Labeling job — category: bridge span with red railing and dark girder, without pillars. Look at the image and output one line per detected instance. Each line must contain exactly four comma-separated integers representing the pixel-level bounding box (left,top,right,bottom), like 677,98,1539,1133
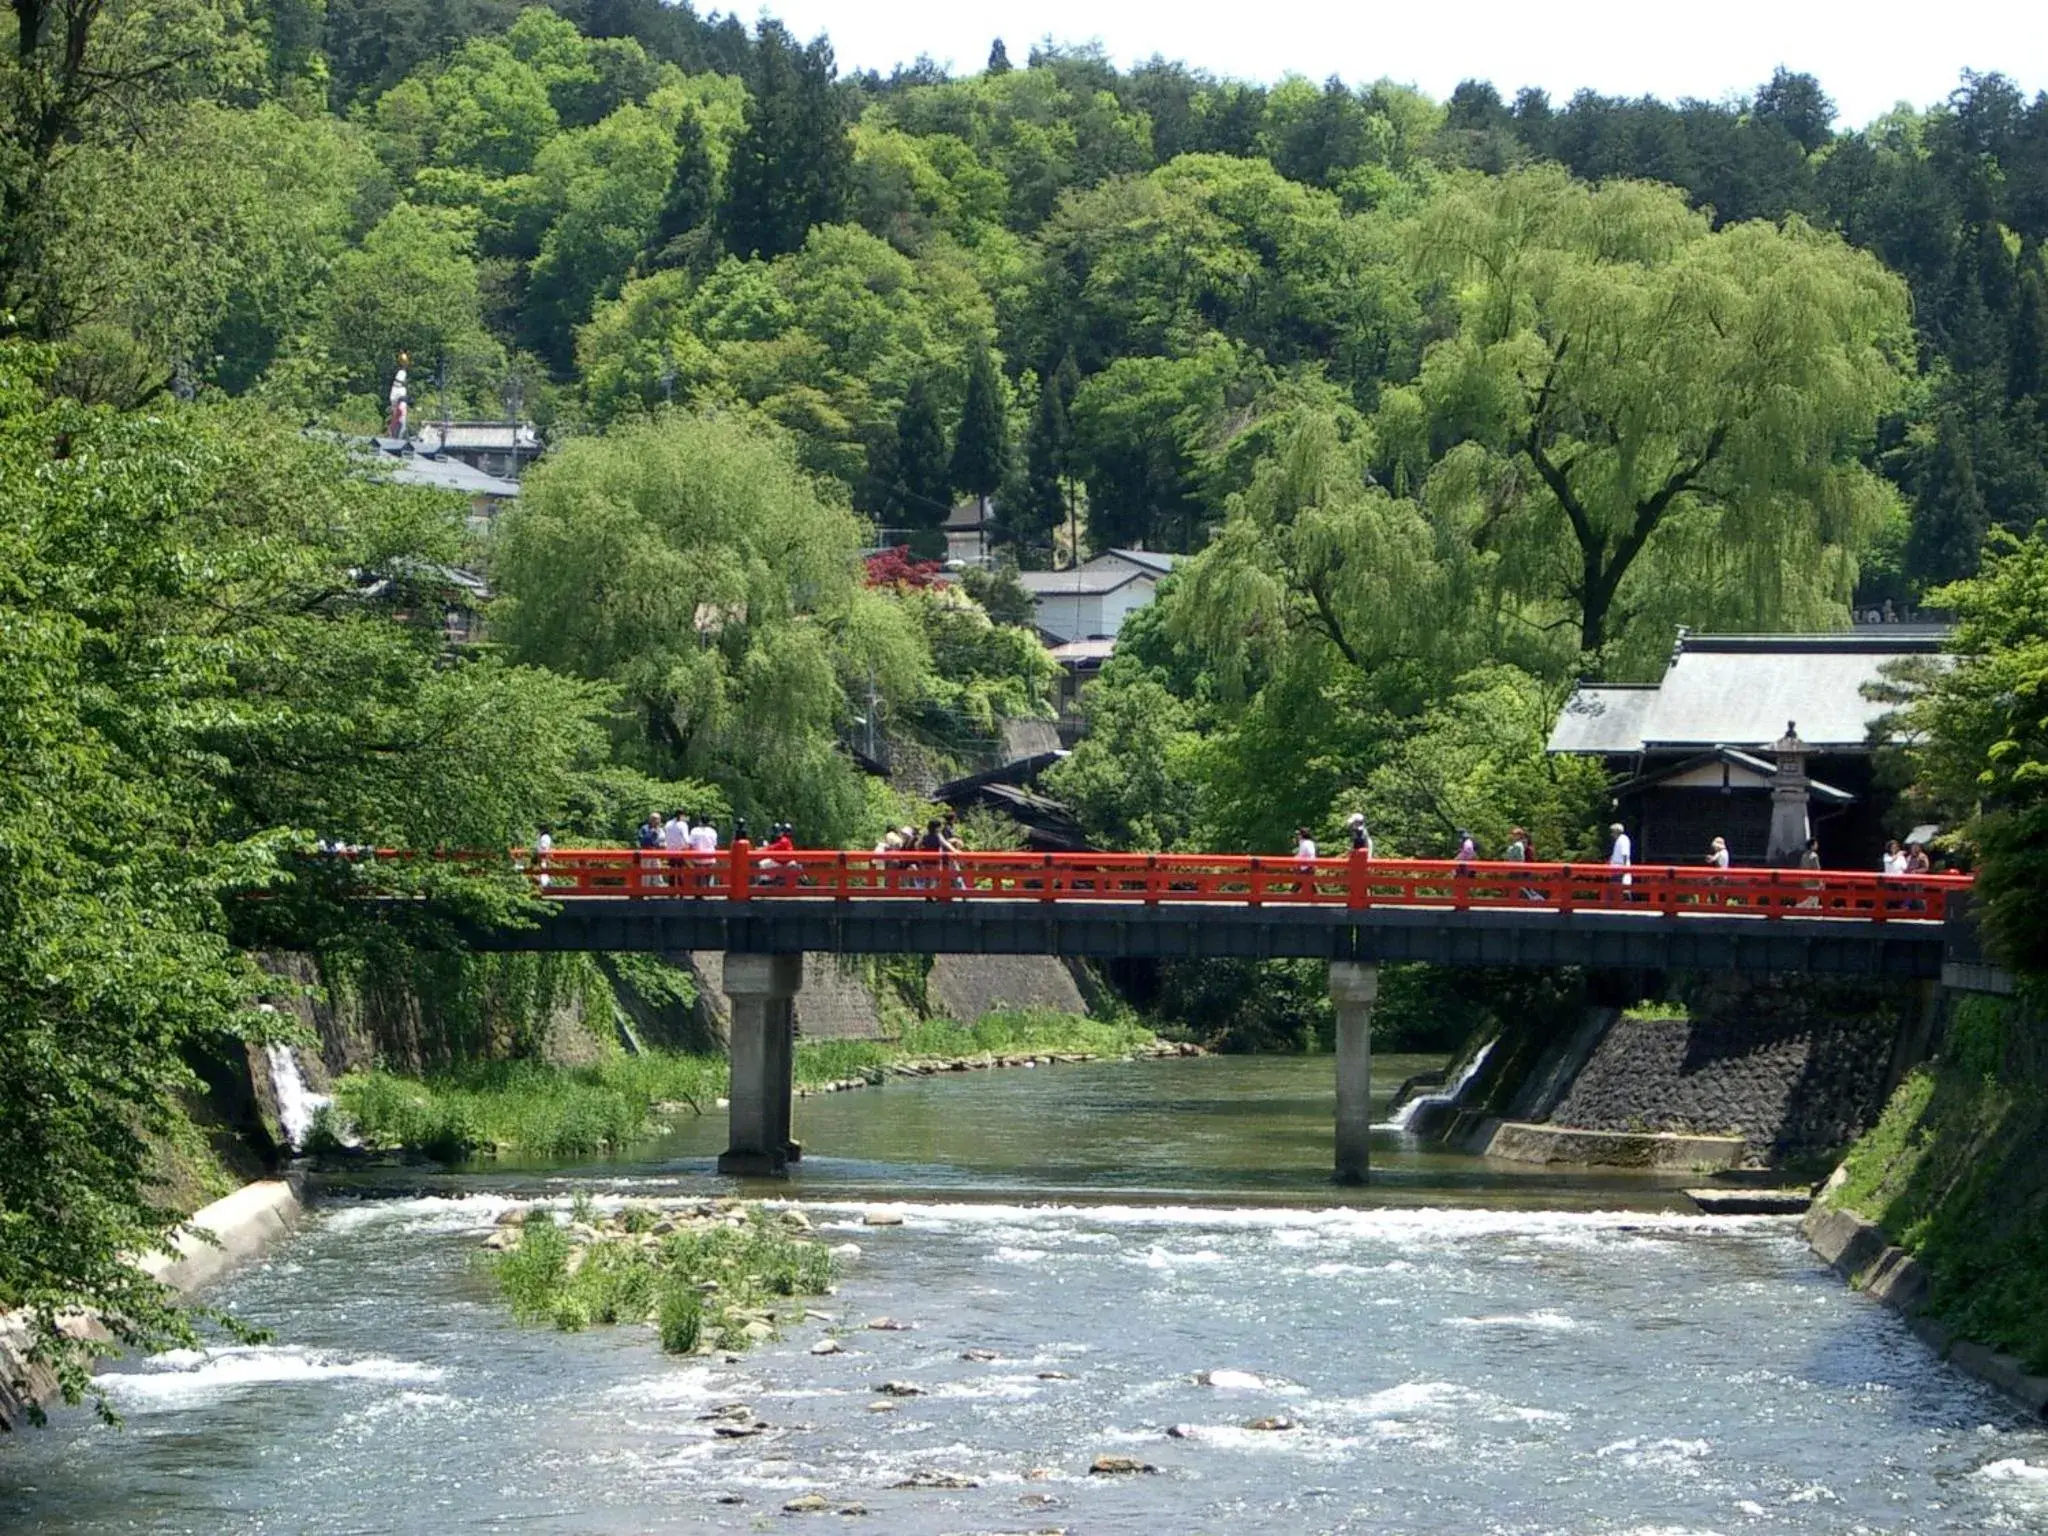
436,848,1970,979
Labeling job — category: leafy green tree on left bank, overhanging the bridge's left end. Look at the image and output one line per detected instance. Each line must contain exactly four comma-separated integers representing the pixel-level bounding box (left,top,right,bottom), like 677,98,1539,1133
0,344,604,1401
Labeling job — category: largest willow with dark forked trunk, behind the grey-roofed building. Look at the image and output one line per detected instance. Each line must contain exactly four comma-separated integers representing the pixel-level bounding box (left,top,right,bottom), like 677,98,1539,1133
1378,166,1911,659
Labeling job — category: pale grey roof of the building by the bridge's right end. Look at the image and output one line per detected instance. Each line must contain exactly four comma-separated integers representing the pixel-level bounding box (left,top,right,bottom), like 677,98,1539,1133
1550,625,1946,756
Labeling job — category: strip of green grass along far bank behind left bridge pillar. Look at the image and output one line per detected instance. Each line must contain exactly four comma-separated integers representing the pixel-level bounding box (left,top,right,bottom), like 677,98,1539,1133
315,1010,1159,1161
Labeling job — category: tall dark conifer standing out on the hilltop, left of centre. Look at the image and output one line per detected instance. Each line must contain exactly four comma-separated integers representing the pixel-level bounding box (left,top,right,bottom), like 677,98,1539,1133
721,20,854,256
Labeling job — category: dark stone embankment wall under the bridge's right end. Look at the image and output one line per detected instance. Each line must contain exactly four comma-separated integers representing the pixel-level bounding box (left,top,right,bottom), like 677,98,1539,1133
1546,981,1919,1163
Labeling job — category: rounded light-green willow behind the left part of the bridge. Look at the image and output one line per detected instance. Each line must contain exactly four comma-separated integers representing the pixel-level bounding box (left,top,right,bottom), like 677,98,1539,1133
492,412,930,840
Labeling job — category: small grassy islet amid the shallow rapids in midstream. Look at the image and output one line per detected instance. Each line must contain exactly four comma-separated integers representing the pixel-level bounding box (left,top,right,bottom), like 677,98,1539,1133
489,1208,831,1354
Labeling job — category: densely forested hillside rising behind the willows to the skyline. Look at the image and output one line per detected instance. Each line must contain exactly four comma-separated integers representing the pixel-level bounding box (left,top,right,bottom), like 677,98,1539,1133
0,0,2048,581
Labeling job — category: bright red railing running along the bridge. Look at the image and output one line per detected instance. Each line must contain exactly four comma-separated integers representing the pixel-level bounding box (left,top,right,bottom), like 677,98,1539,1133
499,842,1970,922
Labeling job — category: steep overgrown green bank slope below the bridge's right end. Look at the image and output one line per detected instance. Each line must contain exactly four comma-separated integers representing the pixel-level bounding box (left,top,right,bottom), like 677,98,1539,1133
1827,997,2048,1374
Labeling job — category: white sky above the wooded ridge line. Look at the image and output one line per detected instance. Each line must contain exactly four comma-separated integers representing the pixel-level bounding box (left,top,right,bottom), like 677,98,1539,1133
770,0,2048,127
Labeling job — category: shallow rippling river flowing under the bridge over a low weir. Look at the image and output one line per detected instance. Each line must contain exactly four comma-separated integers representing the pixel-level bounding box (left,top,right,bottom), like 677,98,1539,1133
0,1059,2048,1536
